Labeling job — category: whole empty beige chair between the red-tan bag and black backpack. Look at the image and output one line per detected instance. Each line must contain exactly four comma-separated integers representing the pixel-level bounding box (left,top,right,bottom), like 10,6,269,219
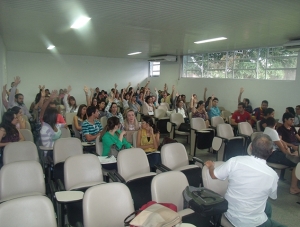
151,171,210,227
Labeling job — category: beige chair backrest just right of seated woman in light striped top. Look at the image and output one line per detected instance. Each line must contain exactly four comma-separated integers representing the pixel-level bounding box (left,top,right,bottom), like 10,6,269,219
53,137,83,165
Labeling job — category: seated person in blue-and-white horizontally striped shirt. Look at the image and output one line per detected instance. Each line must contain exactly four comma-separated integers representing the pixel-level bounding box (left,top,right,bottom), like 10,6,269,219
81,106,102,142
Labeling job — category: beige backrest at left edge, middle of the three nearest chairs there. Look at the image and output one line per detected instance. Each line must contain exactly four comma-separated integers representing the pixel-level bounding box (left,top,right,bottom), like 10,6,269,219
0,161,46,201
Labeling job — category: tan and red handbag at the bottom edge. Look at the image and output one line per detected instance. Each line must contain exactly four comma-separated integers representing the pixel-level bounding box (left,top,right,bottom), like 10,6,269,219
124,201,181,227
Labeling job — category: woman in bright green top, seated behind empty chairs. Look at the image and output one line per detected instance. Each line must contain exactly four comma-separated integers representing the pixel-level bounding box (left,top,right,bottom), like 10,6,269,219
102,117,132,156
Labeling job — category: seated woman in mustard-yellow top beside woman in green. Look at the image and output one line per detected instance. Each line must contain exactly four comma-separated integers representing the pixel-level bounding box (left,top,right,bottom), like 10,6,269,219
136,116,161,170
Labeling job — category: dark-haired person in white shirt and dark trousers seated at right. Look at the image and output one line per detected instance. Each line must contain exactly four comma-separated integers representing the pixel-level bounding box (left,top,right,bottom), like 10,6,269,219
264,117,300,195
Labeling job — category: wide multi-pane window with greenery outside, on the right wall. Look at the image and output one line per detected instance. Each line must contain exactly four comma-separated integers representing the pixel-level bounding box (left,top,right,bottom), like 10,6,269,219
182,47,298,80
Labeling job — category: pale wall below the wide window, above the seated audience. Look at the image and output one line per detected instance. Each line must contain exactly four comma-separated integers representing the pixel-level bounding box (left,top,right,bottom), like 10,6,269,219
149,55,300,118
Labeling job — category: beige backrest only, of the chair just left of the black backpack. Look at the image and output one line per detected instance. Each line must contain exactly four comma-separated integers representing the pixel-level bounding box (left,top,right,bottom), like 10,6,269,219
151,171,189,211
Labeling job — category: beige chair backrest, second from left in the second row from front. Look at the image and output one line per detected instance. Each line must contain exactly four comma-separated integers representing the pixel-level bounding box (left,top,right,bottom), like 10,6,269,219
64,154,103,191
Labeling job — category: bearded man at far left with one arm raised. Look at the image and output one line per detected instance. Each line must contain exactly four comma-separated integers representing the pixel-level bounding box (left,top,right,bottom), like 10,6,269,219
8,76,32,119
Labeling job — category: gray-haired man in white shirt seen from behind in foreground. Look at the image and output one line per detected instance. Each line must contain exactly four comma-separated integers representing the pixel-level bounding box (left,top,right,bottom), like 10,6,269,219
205,134,283,227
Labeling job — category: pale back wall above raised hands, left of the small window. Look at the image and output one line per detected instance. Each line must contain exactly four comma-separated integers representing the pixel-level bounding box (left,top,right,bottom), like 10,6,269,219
7,51,148,107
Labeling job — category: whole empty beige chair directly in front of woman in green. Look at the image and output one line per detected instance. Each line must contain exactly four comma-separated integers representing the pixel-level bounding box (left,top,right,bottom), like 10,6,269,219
111,148,156,209
